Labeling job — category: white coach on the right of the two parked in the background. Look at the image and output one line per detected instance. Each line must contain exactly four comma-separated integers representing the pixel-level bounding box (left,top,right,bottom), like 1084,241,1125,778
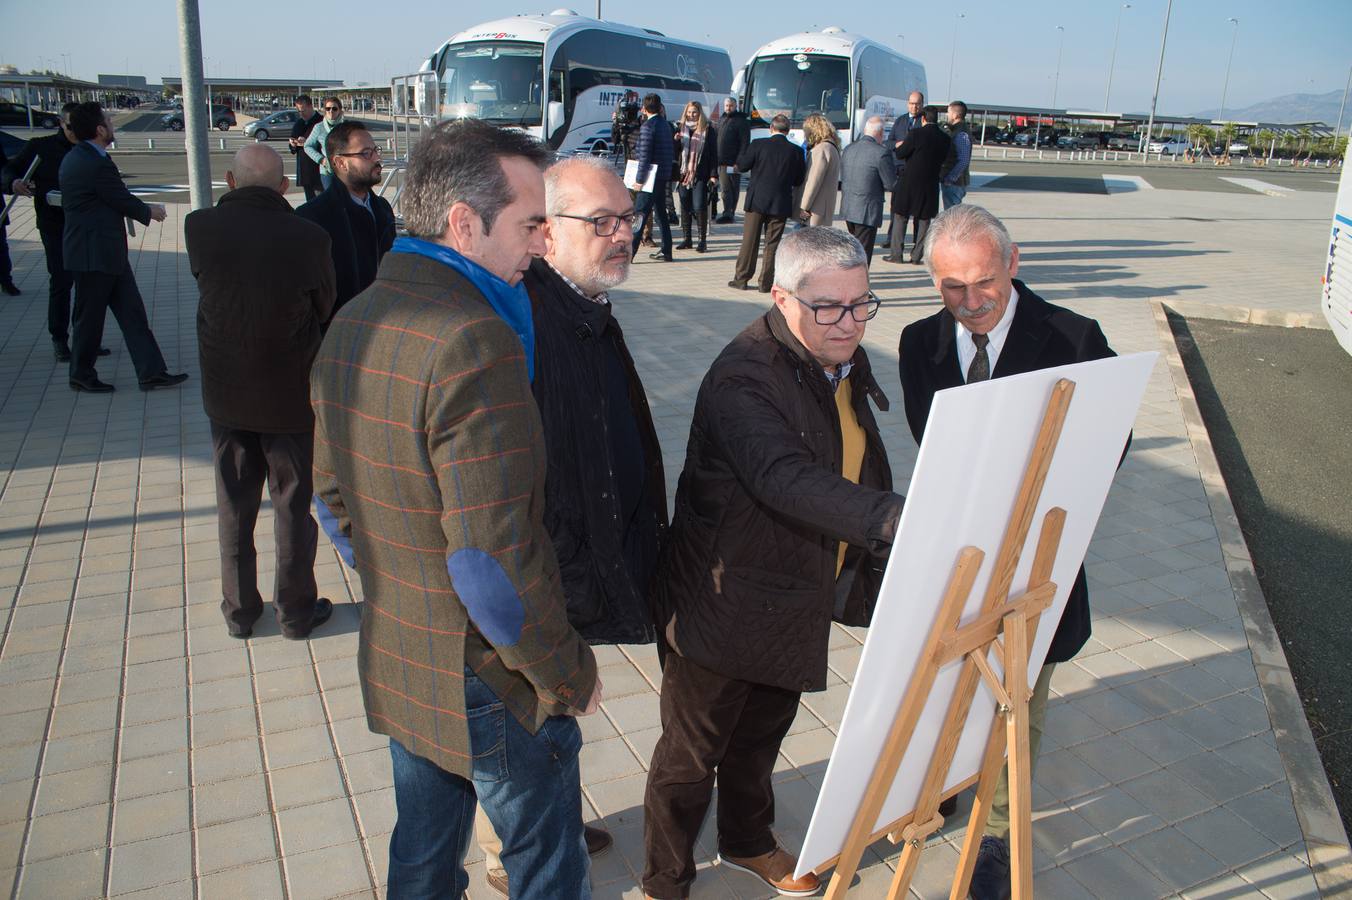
733,26,925,146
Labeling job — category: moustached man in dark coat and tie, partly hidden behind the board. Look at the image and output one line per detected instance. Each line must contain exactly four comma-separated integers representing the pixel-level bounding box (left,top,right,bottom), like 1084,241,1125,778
899,204,1117,900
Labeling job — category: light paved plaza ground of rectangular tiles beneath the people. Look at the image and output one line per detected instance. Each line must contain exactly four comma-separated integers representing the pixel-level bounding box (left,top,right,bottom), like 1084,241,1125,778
0,164,1348,900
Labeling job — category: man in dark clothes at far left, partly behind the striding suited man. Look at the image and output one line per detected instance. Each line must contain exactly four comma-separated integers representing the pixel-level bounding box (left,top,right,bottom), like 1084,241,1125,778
0,103,80,362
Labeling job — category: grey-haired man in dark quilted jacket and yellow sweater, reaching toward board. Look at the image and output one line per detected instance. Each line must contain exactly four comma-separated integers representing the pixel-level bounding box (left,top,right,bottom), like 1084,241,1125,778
642,227,903,899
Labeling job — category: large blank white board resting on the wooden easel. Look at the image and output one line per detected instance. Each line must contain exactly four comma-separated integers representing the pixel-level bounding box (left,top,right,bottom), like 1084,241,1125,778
798,353,1159,874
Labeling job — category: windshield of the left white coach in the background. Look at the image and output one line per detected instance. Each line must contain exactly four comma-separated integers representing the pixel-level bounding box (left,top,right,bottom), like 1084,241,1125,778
438,41,545,126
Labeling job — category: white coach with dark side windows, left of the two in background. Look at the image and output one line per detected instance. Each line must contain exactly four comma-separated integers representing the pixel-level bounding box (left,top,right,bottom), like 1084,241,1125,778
423,9,733,154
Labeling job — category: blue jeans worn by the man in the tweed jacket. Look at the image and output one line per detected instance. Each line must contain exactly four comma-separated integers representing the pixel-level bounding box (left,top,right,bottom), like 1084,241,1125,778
388,670,591,900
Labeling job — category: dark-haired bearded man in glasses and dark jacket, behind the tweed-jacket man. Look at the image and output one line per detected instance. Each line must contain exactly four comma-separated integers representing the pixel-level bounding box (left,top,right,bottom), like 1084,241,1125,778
296,122,395,312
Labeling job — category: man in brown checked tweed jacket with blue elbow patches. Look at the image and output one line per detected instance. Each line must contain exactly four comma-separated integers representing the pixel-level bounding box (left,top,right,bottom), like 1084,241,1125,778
311,120,600,899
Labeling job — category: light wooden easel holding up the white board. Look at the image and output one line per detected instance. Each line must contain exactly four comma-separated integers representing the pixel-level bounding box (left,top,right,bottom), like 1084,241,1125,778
817,378,1075,900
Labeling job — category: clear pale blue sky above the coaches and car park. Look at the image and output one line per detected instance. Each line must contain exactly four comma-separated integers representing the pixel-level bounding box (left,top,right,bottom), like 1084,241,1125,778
0,0,1352,115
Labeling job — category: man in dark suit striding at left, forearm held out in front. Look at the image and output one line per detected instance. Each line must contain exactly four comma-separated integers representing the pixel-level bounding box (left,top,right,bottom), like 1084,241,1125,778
59,103,188,393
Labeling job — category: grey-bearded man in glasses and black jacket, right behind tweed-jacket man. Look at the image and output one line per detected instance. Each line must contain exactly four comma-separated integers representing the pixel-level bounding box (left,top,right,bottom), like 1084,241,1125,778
475,157,667,896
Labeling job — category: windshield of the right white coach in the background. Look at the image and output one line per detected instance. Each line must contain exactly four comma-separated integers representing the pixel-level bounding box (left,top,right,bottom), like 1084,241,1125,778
749,53,849,128
